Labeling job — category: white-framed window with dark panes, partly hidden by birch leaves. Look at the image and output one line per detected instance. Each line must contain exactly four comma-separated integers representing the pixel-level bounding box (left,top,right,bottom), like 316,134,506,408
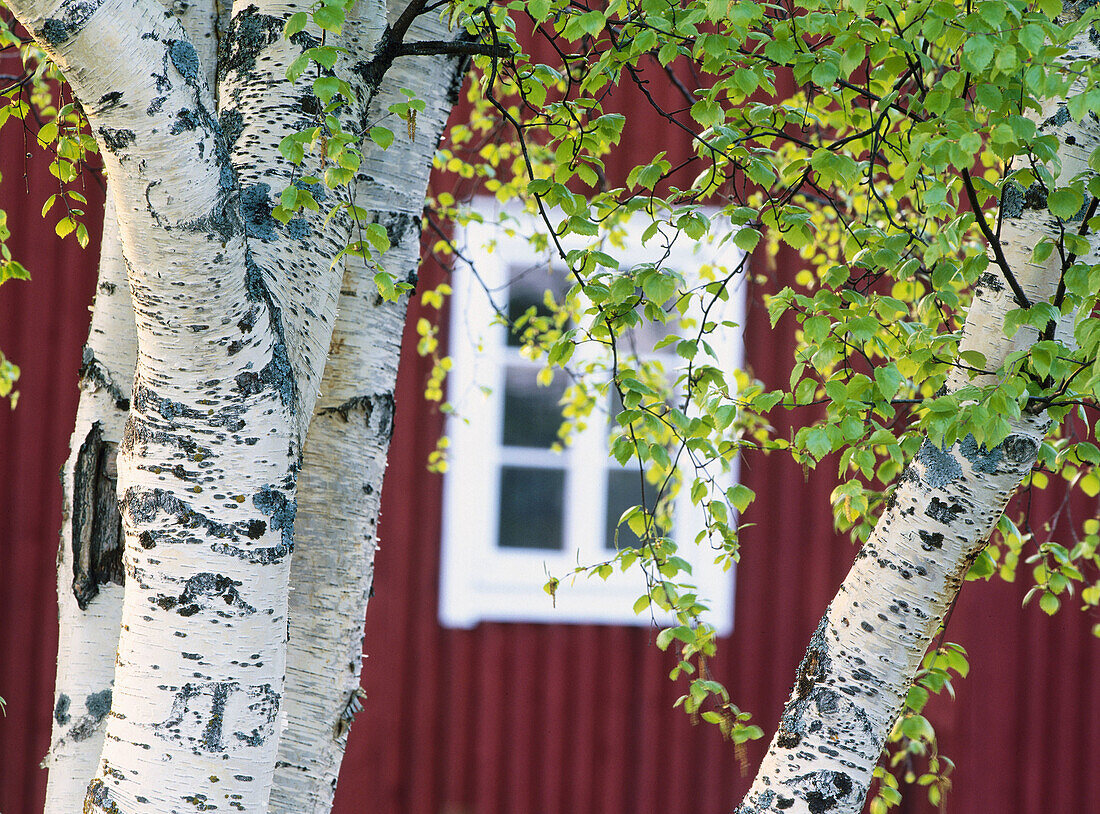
439,206,743,634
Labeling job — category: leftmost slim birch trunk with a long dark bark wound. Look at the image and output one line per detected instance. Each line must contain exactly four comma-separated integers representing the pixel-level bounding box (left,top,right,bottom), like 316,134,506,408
44,2,218,814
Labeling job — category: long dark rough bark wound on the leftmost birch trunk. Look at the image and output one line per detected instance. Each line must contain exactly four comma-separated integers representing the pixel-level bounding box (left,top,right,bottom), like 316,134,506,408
72,421,125,611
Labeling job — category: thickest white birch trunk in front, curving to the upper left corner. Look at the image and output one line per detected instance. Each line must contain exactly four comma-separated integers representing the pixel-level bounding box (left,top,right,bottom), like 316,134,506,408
3,2,339,812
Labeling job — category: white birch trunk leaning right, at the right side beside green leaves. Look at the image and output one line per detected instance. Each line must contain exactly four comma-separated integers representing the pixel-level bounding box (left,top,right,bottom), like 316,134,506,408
737,37,1100,814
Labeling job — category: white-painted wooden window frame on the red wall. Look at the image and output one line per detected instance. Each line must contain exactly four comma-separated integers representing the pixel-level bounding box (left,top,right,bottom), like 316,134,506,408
439,204,745,635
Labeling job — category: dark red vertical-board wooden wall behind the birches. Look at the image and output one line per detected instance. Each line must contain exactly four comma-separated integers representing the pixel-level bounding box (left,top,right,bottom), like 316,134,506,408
0,55,1100,814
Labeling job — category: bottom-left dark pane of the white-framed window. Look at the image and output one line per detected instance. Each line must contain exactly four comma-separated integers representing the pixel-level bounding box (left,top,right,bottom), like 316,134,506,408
496,466,565,551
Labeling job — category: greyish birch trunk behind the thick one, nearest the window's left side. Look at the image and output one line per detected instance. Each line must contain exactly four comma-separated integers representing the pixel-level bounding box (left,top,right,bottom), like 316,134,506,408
271,7,461,814
